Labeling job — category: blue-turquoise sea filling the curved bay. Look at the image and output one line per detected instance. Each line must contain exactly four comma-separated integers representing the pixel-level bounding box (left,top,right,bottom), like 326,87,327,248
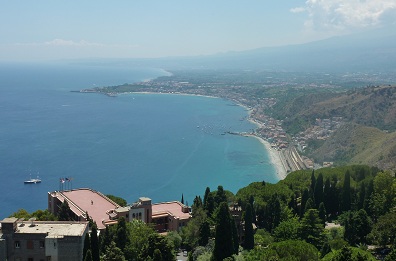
0,63,278,218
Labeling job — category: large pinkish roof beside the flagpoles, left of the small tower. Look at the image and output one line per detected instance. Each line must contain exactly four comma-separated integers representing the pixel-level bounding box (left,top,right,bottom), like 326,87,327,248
52,189,120,229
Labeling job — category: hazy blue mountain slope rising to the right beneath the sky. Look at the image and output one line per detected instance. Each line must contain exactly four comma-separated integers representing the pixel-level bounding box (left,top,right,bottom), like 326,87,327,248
74,28,396,72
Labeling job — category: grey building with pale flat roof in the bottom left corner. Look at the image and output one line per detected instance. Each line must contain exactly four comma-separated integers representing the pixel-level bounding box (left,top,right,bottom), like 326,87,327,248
0,218,88,261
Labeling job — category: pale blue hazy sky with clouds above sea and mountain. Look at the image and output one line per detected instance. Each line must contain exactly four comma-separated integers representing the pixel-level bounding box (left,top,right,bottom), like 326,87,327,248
0,0,396,61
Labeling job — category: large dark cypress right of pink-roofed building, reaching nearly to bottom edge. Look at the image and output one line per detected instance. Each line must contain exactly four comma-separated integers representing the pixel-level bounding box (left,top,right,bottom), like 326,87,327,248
213,202,234,261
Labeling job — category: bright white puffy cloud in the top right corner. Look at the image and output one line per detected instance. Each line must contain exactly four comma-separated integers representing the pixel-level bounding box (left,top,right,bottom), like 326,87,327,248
291,0,396,32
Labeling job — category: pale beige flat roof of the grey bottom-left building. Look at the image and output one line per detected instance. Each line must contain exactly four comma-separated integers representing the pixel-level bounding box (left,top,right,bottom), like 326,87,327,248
16,221,88,238
